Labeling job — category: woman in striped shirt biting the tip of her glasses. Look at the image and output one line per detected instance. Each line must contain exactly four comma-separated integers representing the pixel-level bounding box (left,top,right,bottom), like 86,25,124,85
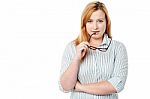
59,2,128,99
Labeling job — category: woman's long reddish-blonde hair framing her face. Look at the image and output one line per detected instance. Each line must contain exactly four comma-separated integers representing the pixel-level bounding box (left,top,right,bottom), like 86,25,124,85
74,1,112,45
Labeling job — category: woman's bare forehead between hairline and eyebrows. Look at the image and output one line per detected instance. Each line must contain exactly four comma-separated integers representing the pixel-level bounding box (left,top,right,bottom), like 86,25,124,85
90,10,105,19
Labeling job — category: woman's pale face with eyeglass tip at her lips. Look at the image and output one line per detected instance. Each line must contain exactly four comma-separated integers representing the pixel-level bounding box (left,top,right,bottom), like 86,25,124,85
86,10,106,39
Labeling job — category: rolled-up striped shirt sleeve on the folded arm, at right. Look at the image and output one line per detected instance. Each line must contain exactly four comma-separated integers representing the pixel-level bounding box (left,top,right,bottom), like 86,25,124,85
108,43,128,93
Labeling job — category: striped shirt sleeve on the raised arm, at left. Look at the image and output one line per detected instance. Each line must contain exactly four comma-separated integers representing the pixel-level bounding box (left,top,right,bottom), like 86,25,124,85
58,42,76,92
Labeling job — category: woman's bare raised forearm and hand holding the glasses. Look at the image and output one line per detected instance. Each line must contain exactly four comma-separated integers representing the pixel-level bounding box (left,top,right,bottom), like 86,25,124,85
60,42,88,91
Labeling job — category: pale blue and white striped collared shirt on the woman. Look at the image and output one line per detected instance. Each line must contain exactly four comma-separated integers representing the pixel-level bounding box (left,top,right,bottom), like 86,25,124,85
59,35,128,99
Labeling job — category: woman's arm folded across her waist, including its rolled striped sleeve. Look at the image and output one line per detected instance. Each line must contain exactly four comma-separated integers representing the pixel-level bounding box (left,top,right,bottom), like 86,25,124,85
75,44,128,95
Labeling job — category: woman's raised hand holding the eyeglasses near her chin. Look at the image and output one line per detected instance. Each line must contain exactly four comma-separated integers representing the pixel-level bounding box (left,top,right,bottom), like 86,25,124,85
75,42,89,60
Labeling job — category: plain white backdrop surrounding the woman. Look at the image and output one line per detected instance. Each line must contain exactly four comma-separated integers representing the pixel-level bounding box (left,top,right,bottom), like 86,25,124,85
0,0,150,99
